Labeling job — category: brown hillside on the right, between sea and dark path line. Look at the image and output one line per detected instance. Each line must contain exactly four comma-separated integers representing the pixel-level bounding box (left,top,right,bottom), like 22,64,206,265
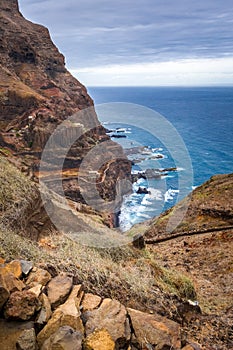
144,174,233,244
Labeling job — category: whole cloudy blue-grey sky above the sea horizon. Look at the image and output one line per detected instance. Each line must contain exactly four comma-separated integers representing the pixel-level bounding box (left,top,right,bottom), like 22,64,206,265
19,0,233,86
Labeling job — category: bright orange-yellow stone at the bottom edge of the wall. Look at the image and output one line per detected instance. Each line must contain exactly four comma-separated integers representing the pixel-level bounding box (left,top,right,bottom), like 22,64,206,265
83,329,115,350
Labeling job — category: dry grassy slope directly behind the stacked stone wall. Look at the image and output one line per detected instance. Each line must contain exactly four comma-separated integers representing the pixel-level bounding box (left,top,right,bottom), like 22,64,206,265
0,154,195,310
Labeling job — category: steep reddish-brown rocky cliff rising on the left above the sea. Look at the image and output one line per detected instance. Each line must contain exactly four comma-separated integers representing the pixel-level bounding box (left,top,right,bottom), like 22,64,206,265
0,0,131,224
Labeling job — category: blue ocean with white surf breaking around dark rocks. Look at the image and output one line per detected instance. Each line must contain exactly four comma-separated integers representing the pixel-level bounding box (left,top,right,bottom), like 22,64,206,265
88,87,233,231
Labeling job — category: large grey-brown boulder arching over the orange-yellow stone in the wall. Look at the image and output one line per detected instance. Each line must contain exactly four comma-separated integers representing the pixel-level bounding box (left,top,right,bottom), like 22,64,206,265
84,299,130,347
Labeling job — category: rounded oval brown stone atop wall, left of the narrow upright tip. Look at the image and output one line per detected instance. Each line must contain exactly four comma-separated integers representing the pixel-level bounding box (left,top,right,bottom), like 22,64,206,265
47,273,73,309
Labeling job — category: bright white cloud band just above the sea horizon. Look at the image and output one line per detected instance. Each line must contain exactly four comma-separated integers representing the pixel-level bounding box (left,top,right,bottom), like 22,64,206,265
71,57,233,86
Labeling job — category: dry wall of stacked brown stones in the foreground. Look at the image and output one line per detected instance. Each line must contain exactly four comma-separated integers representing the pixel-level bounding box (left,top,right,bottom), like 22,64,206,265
0,260,187,350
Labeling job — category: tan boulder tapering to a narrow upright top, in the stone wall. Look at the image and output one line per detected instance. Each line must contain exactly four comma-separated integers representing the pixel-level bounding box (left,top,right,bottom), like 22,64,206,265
37,285,84,346
